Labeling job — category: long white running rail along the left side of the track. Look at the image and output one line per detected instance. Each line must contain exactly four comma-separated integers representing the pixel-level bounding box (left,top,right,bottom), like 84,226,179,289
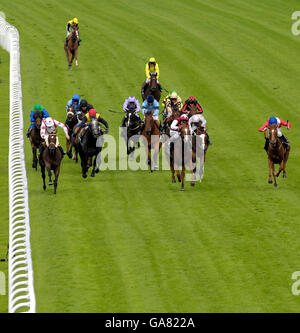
0,16,35,313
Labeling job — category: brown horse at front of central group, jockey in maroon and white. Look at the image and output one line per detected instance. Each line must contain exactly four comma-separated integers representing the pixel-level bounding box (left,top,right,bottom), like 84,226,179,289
165,123,195,191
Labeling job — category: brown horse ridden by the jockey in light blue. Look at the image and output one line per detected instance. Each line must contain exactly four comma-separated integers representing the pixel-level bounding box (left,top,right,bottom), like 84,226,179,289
142,110,161,172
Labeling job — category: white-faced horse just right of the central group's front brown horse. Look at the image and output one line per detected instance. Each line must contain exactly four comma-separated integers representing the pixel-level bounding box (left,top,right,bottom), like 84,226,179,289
192,122,208,182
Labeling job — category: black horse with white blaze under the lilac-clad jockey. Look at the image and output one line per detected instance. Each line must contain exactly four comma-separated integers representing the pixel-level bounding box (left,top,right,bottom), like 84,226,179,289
124,110,141,160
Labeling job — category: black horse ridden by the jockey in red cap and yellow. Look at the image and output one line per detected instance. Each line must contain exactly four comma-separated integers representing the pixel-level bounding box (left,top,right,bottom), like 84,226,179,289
79,119,104,178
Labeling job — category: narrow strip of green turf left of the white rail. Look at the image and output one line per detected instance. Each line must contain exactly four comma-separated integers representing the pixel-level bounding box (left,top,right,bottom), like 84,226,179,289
0,48,9,313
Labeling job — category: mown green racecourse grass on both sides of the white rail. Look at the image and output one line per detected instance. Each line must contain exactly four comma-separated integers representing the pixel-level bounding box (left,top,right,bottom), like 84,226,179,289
0,0,300,312
